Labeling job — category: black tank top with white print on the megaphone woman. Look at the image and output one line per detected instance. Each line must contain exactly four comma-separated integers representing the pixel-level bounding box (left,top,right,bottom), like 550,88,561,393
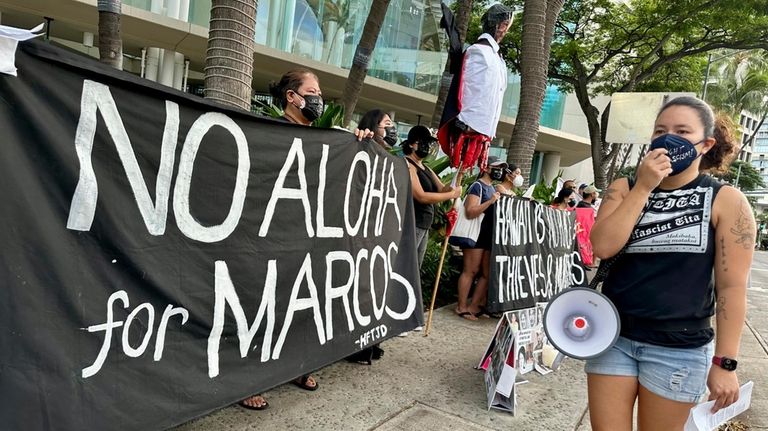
603,175,723,348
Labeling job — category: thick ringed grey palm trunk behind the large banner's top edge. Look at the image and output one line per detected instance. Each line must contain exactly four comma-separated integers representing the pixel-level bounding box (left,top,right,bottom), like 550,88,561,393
205,0,258,110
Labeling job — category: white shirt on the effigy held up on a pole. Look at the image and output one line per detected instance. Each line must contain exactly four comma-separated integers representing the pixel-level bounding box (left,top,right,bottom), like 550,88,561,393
459,33,507,138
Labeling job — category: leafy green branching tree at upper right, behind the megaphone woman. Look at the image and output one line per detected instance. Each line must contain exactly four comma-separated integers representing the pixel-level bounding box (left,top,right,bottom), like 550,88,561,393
496,0,768,188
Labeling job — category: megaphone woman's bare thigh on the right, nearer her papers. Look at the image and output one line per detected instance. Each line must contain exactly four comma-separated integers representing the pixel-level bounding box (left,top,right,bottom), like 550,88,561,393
637,385,694,431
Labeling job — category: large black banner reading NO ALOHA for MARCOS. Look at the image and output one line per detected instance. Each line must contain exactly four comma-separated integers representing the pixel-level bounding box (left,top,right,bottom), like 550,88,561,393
0,43,423,430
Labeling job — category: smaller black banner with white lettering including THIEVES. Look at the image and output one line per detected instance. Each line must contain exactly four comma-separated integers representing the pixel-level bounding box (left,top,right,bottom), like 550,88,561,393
488,197,587,312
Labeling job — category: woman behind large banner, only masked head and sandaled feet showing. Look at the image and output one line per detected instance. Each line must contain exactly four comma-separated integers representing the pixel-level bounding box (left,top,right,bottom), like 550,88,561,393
239,69,325,410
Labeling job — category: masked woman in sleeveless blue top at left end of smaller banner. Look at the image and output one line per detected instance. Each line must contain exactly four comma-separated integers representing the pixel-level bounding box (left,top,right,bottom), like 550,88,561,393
455,156,507,320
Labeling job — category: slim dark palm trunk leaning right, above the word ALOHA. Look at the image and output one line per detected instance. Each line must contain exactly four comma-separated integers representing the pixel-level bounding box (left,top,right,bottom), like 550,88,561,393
342,0,390,125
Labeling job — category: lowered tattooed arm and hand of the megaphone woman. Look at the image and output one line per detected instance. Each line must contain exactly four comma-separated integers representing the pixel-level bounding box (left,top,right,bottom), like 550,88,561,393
707,187,756,411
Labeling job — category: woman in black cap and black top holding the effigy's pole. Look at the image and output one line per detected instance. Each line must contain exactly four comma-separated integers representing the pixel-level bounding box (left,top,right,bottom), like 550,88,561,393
403,126,461,267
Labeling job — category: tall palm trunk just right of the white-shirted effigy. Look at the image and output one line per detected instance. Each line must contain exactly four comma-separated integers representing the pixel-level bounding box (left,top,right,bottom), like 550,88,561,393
507,0,565,184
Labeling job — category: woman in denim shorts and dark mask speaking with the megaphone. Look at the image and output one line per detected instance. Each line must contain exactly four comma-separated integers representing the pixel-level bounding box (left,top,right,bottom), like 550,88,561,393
585,97,756,431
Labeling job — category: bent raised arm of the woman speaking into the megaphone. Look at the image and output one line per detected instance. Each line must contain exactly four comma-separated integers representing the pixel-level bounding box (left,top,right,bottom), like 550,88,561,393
590,149,672,259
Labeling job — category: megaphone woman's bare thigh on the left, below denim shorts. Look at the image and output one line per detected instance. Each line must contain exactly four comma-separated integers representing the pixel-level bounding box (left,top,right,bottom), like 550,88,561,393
587,374,639,431
